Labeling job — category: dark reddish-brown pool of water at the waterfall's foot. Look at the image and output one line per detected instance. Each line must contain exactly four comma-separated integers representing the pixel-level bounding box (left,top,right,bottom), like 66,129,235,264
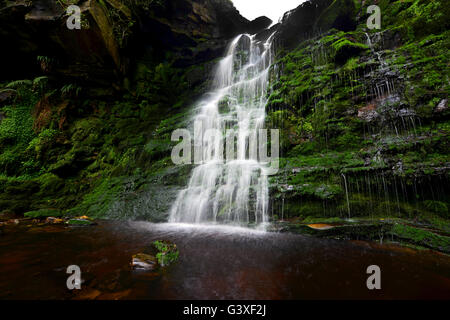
0,222,450,299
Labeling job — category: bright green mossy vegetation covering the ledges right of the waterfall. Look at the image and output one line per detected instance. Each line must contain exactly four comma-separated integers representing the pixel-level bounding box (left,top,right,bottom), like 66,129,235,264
267,0,450,238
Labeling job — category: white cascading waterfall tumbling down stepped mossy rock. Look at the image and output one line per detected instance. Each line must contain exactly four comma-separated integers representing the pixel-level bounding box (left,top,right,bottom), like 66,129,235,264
170,34,273,225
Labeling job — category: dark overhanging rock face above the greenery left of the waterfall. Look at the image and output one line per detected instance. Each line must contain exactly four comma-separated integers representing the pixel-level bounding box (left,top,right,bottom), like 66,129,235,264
0,0,270,87
